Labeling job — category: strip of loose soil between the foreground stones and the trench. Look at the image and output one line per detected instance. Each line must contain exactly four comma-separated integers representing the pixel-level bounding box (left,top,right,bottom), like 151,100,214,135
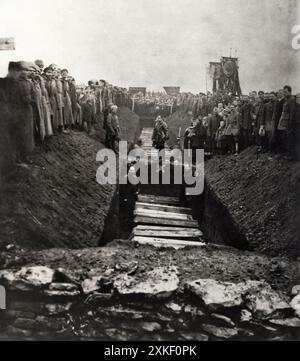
0,241,300,293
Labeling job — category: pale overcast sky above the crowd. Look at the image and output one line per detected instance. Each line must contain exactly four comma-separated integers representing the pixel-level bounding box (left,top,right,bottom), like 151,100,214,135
0,0,300,93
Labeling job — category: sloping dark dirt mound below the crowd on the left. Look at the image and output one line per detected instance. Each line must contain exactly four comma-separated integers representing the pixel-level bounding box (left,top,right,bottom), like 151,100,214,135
0,132,115,248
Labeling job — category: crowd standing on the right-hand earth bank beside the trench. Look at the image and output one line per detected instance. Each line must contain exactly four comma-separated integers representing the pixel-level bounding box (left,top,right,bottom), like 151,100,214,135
181,86,300,160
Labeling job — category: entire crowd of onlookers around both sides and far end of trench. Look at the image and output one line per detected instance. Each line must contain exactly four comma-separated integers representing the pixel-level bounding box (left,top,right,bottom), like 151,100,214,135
0,60,300,163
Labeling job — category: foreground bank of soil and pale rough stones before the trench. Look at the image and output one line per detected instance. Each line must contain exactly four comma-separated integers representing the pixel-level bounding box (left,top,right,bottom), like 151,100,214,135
0,241,300,341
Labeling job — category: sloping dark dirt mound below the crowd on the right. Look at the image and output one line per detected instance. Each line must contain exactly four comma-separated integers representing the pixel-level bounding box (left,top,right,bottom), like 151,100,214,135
205,147,300,259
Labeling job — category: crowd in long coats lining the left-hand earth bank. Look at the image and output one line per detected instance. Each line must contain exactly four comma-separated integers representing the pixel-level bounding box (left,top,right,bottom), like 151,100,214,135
0,60,129,161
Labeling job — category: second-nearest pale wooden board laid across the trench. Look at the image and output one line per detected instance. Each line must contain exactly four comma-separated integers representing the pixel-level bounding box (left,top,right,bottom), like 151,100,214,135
132,227,202,241
